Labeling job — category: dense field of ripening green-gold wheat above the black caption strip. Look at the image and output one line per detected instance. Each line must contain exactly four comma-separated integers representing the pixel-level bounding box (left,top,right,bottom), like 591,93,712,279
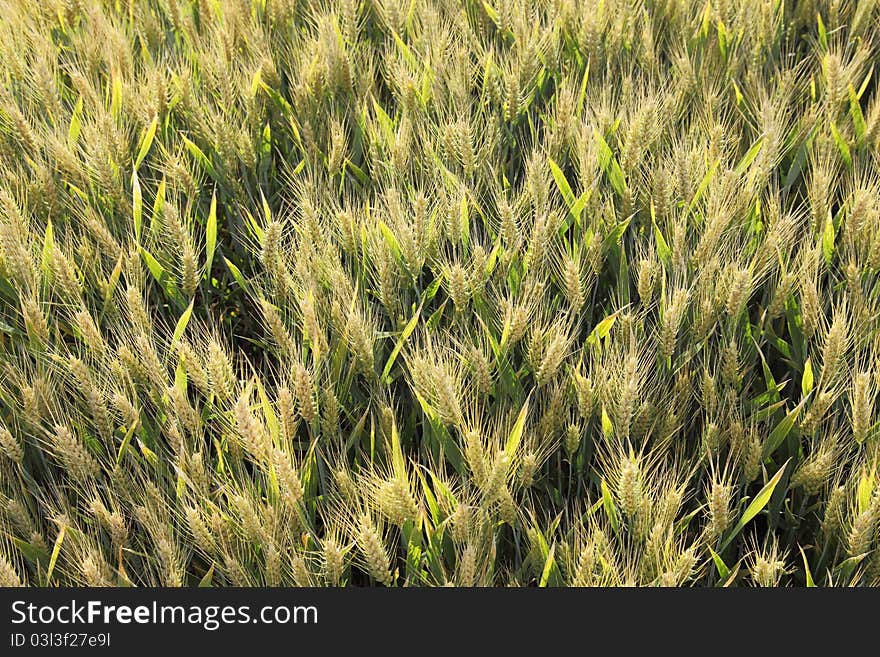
0,0,880,586
